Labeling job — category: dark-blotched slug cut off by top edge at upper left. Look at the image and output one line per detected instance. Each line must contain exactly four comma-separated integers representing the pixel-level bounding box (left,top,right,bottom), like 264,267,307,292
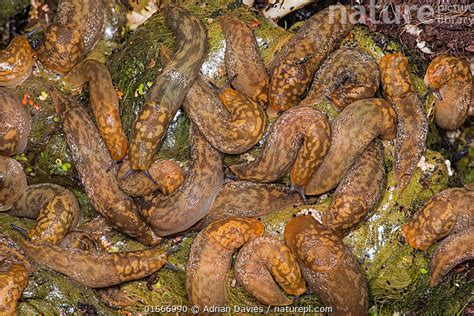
37,0,106,74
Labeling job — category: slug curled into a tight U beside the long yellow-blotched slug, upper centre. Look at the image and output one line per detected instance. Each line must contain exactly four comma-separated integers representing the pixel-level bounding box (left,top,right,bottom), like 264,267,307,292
160,46,267,154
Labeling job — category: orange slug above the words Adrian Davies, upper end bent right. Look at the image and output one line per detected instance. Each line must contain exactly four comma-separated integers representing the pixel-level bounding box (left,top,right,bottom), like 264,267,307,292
186,218,264,310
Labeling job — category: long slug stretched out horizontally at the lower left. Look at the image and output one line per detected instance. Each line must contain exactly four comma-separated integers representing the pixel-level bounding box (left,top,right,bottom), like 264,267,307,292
20,240,168,288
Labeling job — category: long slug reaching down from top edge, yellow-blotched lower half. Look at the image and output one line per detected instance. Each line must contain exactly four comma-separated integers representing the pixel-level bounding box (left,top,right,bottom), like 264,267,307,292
129,5,207,170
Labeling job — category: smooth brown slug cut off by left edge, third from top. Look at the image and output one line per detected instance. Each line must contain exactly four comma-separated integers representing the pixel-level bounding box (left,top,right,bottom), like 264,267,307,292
0,156,27,212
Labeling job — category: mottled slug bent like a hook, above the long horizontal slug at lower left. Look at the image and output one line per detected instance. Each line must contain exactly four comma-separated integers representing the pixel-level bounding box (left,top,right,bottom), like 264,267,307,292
9,183,82,245
